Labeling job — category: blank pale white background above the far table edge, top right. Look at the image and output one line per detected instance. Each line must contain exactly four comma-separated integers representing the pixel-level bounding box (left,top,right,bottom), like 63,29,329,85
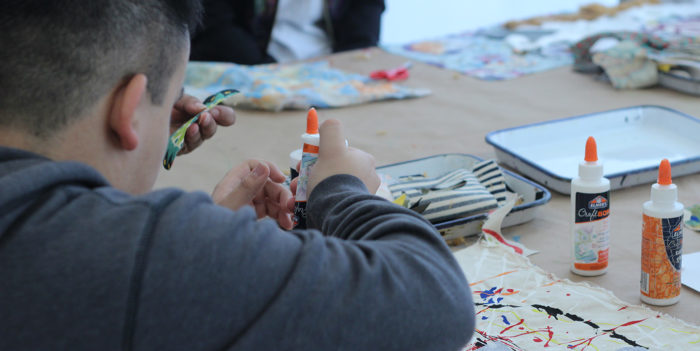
380,0,618,44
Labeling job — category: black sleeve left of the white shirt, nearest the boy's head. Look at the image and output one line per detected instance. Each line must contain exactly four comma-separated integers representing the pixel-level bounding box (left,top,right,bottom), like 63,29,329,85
190,0,274,65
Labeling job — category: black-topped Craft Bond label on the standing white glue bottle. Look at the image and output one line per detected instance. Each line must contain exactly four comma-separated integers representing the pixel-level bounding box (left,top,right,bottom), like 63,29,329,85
574,191,610,271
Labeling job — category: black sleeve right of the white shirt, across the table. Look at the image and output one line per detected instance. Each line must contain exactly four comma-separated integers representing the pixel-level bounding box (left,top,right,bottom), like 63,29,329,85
333,0,384,52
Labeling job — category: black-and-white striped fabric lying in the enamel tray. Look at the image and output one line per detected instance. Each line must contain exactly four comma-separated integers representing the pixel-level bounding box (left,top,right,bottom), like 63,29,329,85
389,160,506,223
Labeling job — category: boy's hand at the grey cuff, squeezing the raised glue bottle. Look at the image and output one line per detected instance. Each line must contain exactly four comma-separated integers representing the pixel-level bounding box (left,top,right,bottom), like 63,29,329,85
308,119,380,194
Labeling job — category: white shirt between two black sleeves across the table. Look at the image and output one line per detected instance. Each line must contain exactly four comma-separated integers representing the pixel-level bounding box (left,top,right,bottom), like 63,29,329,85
267,0,331,62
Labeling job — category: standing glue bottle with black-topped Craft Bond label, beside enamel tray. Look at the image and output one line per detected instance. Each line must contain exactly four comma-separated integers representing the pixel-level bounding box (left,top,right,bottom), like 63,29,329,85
571,137,610,276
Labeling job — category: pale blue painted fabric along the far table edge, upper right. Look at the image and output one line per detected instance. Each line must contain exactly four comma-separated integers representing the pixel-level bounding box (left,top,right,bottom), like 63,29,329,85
383,4,700,80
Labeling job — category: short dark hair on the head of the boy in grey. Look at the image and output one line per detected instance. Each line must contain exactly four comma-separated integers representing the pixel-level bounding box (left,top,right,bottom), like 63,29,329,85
0,0,202,137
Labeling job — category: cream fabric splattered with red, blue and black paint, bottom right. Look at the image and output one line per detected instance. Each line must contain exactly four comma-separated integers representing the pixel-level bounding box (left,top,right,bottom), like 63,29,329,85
455,241,700,351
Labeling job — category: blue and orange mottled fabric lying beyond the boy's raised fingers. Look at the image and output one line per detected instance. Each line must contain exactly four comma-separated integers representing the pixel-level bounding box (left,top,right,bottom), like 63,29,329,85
185,61,430,111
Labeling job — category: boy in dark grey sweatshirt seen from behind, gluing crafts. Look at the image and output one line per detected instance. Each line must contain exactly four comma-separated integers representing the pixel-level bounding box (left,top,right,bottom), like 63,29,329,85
0,0,474,350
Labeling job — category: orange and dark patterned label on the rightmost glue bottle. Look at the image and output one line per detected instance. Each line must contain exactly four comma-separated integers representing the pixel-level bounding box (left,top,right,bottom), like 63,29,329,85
640,215,683,299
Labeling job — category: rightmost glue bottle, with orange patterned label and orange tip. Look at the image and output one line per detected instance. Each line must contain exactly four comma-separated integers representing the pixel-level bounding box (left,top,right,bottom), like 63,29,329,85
640,159,683,306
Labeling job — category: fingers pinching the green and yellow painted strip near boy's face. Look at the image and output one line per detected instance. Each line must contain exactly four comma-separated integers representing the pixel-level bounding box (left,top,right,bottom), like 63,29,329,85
170,95,236,155
